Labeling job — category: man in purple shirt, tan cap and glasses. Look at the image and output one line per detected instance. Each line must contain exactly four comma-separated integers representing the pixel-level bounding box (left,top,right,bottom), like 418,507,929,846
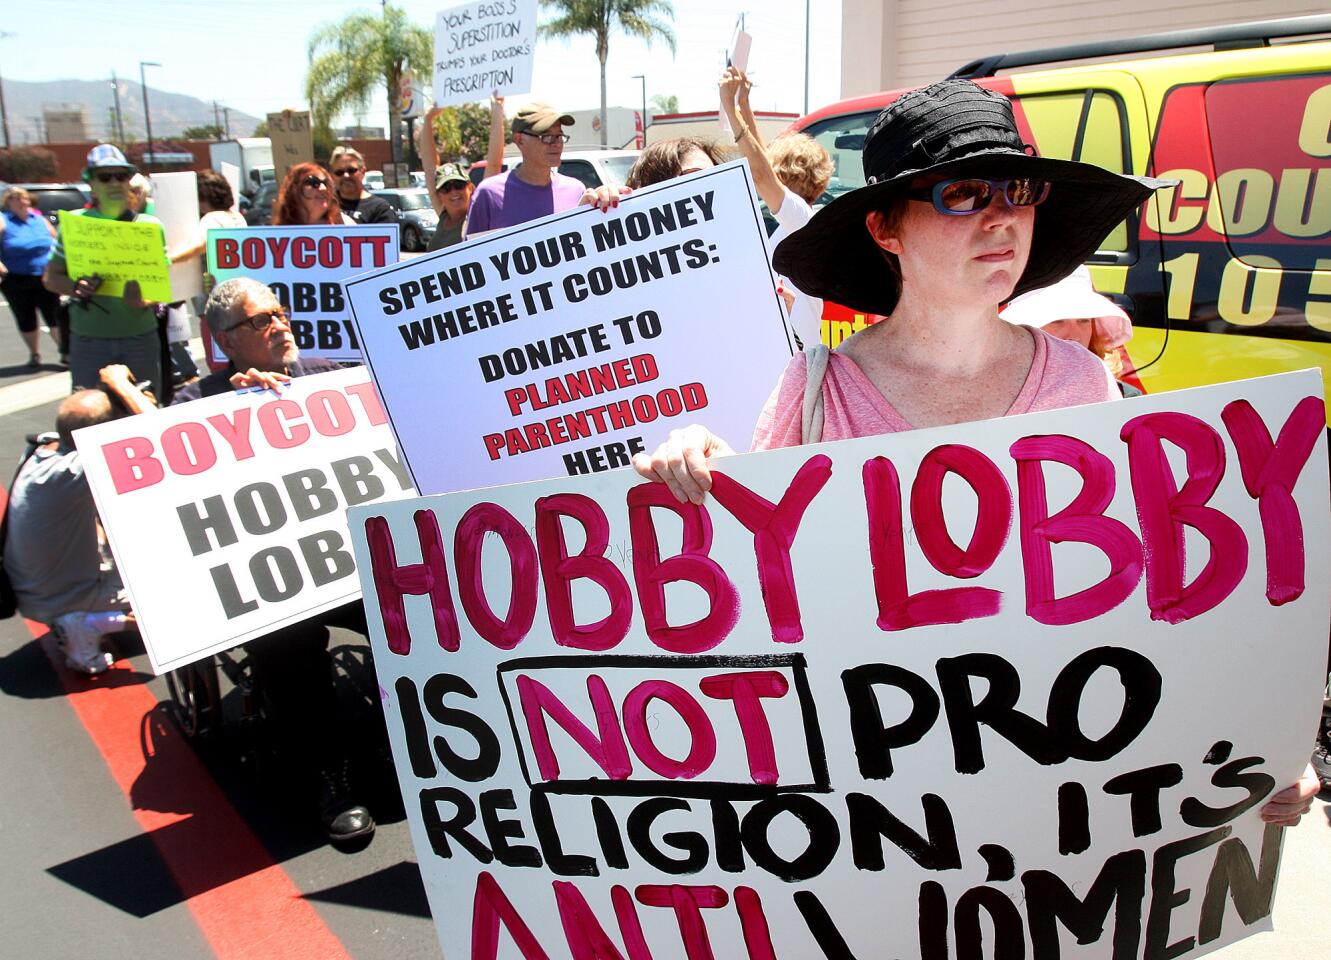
467,104,586,237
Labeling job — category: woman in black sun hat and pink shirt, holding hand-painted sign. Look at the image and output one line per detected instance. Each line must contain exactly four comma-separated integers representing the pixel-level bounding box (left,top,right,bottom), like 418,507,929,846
634,80,1319,824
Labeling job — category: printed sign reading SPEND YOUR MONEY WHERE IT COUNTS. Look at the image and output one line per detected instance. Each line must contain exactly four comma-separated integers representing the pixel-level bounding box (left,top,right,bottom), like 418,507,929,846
346,164,793,493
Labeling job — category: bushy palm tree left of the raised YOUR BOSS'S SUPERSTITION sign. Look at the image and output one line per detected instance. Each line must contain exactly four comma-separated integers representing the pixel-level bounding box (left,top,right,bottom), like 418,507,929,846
305,4,434,160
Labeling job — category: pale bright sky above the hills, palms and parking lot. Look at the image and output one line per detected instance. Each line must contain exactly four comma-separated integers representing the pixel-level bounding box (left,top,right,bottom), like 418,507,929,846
10,0,841,125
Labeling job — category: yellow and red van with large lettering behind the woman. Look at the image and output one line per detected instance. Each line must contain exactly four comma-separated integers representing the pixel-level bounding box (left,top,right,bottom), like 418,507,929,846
796,16,1331,412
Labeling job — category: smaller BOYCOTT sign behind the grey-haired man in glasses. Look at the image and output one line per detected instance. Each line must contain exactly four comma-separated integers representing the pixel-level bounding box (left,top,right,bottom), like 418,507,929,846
204,224,398,362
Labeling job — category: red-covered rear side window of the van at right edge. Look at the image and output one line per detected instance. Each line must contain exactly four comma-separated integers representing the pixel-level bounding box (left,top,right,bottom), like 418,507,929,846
1206,73,1331,270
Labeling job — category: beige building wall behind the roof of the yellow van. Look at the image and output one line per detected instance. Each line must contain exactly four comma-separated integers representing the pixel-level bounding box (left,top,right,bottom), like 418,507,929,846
841,0,1331,97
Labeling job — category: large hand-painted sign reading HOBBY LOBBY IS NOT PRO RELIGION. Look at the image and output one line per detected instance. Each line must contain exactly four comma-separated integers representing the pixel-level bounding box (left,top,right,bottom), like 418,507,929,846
350,371,1331,960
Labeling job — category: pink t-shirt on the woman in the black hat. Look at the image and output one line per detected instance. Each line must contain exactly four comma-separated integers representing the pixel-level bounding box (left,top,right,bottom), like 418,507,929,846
749,328,1119,450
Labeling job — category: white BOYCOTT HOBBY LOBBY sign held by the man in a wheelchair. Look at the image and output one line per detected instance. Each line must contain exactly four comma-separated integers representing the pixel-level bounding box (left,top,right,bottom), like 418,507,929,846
75,367,414,672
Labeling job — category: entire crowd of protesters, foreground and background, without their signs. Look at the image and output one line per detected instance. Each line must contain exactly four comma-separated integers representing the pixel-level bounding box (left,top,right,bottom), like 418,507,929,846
0,68,1319,840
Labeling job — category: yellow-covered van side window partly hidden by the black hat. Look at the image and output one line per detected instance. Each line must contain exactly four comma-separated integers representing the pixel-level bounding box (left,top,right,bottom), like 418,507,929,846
1012,91,1129,253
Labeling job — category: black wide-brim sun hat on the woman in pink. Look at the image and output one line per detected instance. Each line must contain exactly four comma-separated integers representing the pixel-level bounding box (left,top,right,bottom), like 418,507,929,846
772,80,1175,314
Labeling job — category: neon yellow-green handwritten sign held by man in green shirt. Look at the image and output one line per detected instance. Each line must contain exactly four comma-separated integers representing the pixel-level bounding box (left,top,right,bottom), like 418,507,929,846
60,210,172,302
